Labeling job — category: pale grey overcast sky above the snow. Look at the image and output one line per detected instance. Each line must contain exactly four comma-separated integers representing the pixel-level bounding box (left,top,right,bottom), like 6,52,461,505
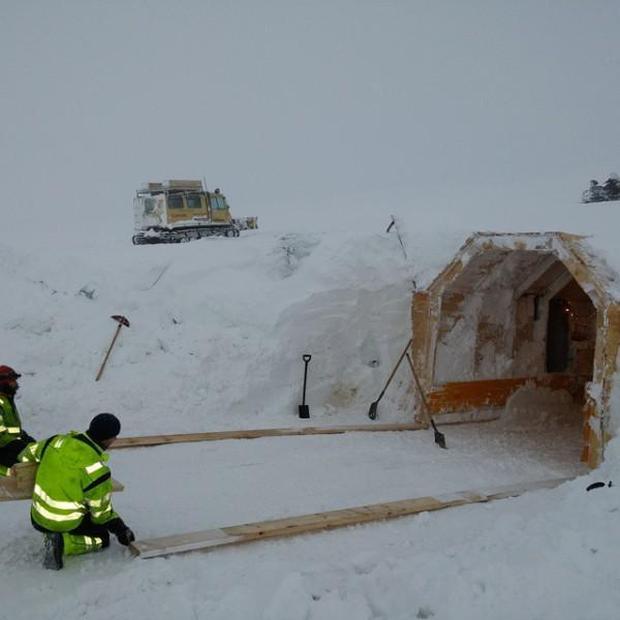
0,0,620,239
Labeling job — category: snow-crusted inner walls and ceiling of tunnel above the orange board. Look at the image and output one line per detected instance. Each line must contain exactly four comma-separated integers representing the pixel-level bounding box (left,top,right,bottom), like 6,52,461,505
433,251,596,390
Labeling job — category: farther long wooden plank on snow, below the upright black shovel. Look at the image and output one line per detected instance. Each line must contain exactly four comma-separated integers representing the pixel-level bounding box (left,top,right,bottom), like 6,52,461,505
109,423,426,450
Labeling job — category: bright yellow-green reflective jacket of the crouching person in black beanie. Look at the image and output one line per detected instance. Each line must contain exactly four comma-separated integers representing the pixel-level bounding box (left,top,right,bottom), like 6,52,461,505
20,432,118,532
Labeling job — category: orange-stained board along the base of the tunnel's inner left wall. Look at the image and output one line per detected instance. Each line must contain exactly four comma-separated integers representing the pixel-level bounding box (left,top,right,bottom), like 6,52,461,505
428,374,579,413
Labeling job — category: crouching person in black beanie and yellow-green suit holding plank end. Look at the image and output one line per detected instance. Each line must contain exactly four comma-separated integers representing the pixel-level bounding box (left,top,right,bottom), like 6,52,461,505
20,413,135,570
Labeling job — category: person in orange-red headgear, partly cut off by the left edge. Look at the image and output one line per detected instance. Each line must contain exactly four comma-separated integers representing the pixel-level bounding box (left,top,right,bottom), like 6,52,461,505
0,365,36,476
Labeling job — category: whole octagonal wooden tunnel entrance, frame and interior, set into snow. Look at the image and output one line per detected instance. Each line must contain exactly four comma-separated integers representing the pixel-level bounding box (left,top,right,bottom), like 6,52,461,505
412,233,620,465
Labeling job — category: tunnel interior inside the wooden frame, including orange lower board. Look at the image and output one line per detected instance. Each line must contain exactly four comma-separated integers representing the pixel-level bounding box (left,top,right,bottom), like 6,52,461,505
414,246,598,468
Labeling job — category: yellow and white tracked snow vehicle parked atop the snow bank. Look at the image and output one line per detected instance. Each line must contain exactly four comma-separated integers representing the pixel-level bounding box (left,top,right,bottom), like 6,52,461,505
132,180,257,245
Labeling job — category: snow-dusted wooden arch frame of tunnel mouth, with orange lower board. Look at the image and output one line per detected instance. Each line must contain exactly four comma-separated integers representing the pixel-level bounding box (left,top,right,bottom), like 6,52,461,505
411,232,620,467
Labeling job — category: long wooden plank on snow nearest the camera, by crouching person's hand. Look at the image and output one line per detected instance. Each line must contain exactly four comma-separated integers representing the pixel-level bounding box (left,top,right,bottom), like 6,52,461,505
131,478,569,558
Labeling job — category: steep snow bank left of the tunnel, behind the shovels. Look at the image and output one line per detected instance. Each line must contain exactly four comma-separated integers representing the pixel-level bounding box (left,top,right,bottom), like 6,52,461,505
0,232,412,435
